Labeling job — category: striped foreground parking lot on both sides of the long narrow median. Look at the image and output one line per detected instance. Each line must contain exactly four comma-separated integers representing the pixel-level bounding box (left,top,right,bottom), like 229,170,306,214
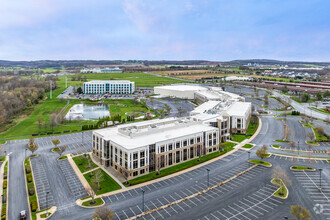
108,162,267,219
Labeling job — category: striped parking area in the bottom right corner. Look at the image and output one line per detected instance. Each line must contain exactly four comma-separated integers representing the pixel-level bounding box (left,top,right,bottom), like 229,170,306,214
292,171,330,219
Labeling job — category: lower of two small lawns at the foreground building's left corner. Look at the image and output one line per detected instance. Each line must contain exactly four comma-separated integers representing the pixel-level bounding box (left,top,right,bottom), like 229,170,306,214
84,168,121,195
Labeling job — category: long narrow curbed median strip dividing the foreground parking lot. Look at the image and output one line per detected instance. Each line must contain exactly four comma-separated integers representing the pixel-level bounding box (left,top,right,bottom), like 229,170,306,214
128,164,258,220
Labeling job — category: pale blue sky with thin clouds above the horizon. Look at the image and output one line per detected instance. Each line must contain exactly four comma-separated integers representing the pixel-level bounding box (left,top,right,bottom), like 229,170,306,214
0,0,330,62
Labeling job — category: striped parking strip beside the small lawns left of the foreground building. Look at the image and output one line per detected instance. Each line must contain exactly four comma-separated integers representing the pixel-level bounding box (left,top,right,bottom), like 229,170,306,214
58,160,87,199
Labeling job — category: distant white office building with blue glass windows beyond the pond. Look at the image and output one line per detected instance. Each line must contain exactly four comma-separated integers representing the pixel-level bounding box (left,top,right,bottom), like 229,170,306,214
83,80,135,94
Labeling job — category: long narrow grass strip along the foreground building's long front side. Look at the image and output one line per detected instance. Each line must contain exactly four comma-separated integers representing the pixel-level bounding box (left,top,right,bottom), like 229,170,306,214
129,142,236,185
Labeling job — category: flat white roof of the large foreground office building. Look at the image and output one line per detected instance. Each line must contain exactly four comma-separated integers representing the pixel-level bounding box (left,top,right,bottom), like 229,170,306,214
94,117,216,150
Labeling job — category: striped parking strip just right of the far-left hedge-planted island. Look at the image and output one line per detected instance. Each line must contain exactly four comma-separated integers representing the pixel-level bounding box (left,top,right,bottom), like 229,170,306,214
31,157,55,209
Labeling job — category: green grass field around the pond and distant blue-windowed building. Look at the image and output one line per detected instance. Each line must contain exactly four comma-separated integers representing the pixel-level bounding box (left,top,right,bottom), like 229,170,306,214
0,73,175,143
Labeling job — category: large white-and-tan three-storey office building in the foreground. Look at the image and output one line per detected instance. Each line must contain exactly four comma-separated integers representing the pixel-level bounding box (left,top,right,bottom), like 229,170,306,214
93,117,219,179
